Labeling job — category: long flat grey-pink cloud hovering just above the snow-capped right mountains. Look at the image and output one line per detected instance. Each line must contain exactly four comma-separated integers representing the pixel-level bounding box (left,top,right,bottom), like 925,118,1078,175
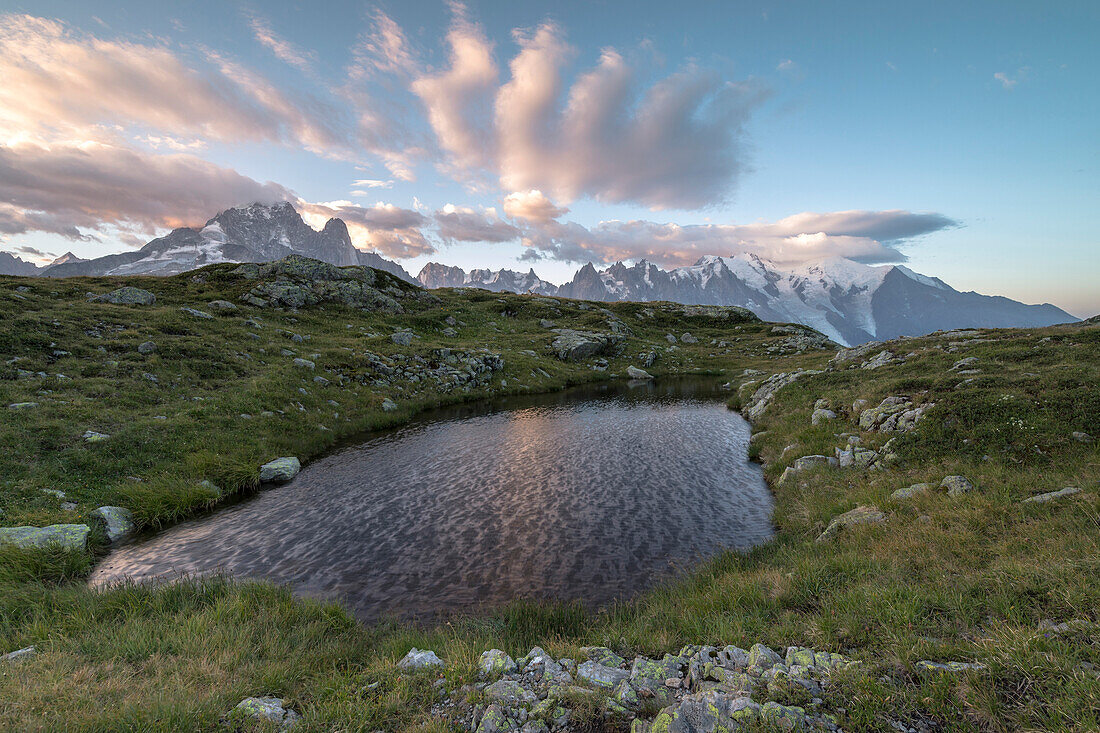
514,211,958,267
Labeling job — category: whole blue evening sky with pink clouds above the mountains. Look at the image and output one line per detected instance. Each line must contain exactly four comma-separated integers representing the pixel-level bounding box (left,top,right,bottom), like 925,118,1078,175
0,0,1100,316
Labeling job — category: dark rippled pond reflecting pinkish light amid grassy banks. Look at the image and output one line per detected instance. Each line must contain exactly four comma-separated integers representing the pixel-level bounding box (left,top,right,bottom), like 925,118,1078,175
92,380,772,621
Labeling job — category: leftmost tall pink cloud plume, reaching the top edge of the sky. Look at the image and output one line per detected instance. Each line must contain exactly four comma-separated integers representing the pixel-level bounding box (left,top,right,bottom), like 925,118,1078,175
411,4,499,169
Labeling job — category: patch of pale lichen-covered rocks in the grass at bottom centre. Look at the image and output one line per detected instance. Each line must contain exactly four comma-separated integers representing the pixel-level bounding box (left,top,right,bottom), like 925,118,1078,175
420,644,858,733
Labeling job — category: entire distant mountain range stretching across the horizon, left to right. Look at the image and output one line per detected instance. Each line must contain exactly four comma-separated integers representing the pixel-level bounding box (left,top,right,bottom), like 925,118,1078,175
0,203,1078,346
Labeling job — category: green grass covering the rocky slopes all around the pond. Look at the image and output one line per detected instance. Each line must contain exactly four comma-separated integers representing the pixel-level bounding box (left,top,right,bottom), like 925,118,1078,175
0,266,1100,731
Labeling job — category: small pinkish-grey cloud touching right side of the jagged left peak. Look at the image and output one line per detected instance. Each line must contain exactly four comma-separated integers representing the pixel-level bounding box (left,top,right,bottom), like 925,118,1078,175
295,199,436,259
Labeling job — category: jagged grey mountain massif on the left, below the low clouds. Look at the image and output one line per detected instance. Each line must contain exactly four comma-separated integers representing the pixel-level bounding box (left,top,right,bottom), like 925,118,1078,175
11,203,416,283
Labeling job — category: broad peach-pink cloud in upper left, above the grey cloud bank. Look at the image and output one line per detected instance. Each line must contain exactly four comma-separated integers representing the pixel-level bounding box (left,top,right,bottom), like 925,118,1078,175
0,14,349,153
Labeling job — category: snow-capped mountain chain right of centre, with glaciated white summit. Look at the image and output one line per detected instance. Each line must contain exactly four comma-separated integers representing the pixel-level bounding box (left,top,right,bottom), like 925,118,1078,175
418,254,1077,344
